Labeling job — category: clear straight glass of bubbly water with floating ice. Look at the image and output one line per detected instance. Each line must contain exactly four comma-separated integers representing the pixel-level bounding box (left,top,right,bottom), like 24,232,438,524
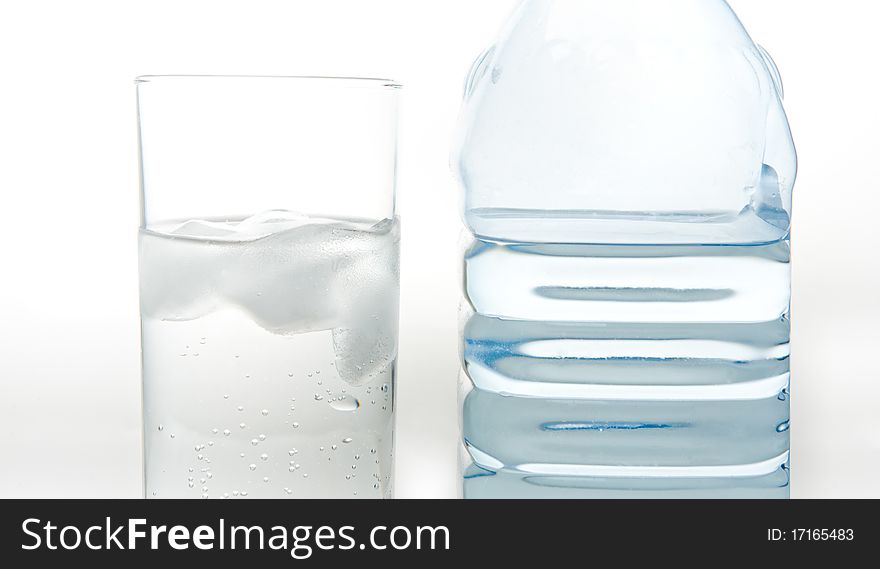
137,76,400,498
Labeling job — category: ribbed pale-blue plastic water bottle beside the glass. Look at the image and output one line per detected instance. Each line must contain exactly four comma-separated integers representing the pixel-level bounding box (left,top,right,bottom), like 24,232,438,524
453,0,797,498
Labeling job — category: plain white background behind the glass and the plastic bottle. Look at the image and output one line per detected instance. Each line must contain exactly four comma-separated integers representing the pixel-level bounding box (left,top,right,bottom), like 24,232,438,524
0,0,880,497
